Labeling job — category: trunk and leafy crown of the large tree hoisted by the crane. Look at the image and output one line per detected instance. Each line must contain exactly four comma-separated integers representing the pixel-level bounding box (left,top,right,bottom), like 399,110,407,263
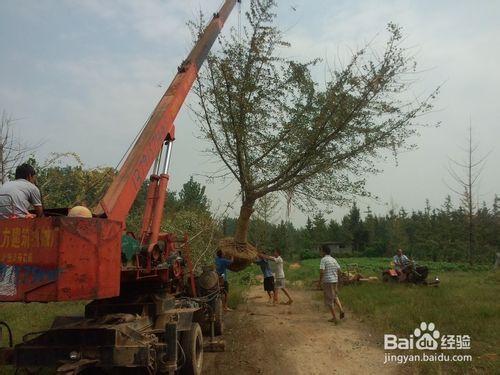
194,0,437,253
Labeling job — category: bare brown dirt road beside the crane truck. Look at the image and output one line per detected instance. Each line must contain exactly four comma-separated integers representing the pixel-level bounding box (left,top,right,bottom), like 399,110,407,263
204,287,396,375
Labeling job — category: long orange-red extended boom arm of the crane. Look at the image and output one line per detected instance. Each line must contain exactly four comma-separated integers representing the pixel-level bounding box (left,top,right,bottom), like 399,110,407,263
94,0,240,222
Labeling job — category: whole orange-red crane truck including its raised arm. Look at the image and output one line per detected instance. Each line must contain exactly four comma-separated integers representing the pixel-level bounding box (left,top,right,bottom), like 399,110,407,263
0,0,239,374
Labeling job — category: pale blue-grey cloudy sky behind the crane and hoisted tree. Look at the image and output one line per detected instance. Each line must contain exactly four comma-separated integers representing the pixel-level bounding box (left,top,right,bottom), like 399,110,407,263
0,0,500,225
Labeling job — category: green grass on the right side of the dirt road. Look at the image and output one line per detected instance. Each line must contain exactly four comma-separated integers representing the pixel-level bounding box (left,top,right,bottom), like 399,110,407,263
286,258,500,373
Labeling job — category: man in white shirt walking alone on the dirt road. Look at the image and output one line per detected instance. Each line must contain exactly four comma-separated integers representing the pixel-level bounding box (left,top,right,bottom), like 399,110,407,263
319,246,345,324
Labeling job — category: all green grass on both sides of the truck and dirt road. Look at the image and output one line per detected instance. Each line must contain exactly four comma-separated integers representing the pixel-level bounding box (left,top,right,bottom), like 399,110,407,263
0,258,500,374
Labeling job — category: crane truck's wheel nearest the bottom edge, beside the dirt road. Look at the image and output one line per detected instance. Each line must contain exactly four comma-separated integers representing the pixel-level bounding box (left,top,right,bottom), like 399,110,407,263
180,323,203,375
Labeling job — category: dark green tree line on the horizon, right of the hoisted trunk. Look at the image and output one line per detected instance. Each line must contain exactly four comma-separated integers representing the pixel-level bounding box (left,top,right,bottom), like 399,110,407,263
222,196,500,263
